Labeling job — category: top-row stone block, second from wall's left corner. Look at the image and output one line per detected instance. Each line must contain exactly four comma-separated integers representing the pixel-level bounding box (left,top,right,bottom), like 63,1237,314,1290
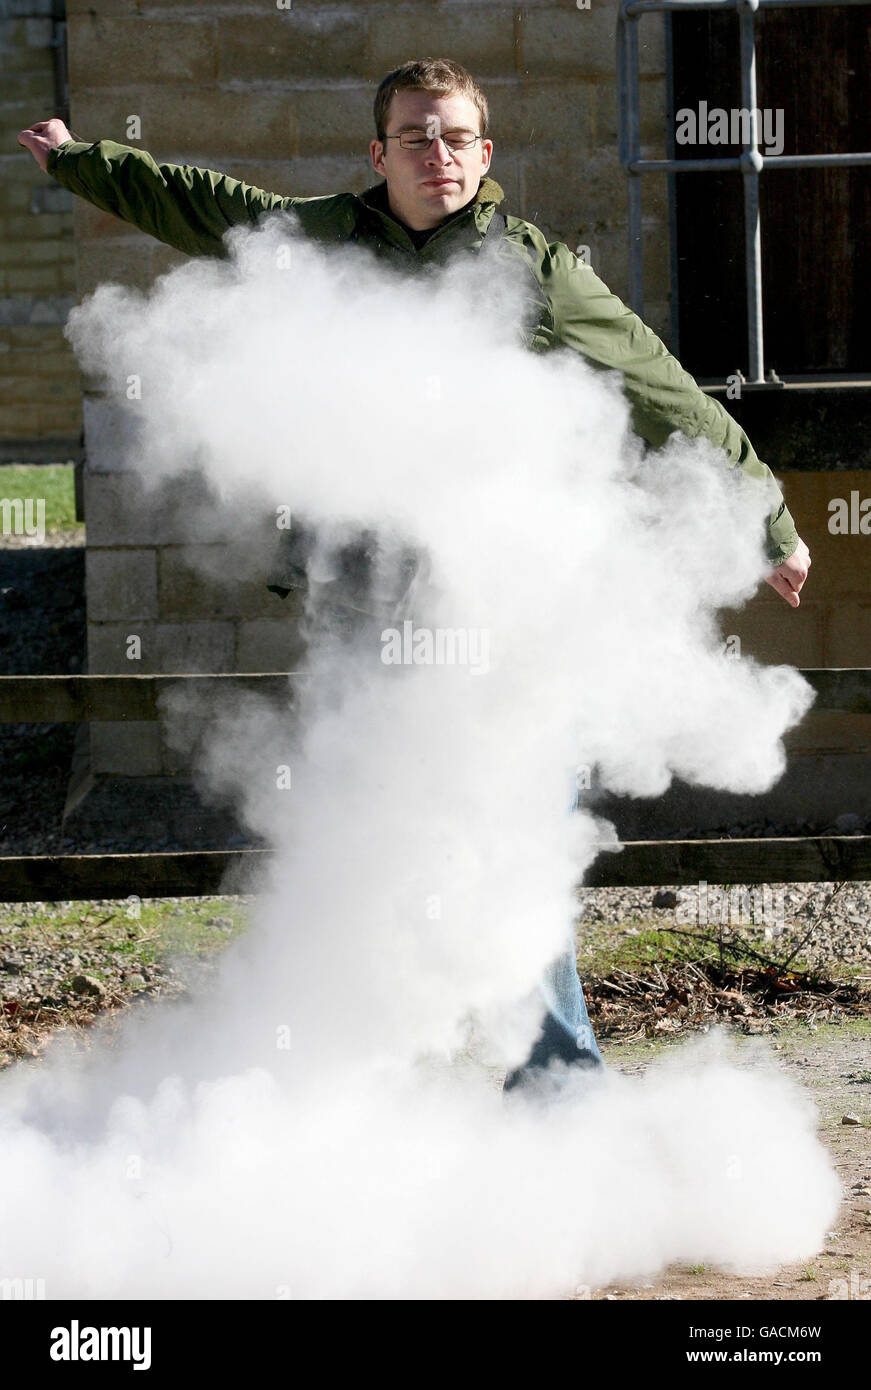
218,7,367,83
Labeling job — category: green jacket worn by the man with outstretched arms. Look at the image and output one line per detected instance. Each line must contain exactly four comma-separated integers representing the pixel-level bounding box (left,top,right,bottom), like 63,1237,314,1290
47,140,799,564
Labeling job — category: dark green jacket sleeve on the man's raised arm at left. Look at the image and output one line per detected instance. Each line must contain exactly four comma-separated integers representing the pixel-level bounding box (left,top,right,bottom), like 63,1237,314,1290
46,140,321,257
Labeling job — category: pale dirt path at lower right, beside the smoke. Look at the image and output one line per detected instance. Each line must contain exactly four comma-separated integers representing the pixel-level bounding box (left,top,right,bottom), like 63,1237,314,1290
589,1020,871,1301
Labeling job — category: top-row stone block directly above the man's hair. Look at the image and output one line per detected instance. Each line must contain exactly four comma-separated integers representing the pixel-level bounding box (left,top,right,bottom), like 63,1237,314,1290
360,4,515,79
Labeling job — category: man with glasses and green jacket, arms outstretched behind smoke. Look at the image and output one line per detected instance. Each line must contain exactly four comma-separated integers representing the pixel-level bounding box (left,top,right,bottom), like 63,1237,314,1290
18,58,810,1087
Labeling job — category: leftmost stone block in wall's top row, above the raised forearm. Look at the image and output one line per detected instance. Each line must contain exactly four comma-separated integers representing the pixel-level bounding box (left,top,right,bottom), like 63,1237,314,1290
68,8,217,89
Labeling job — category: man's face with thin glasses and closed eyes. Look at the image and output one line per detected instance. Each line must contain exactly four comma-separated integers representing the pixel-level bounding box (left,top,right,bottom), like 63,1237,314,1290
370,92,493,232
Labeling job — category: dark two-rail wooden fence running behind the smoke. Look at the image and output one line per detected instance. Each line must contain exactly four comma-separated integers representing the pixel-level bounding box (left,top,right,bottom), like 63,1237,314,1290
0,667,871,902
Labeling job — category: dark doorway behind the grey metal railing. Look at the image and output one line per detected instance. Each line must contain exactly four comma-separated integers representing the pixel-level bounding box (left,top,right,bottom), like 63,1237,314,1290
671,6,871,379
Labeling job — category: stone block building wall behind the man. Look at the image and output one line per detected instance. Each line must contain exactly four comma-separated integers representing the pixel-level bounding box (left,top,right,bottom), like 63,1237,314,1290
0,0,871,834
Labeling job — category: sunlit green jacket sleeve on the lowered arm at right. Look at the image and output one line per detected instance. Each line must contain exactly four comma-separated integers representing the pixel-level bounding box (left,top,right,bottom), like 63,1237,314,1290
542,242,799,566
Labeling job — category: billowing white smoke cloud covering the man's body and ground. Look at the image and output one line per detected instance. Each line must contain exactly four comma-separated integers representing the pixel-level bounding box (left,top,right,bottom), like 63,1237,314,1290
0,211,838,1298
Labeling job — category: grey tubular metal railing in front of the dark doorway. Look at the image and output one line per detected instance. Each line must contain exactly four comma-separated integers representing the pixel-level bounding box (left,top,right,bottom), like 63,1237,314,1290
617,0,871,388
